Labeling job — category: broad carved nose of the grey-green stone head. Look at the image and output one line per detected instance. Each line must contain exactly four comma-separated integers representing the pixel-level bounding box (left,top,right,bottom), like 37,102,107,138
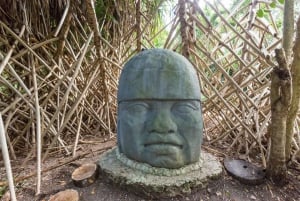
148,109,177,134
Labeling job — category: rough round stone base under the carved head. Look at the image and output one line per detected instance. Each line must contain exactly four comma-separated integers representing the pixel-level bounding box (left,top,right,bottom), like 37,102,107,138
98,148,222,198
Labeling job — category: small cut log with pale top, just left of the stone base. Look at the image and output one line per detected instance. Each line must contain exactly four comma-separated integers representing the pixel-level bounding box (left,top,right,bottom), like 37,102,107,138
72,163,98,187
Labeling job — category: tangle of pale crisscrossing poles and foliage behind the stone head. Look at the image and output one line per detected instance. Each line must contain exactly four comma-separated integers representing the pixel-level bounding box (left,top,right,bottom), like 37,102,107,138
0,0,300,200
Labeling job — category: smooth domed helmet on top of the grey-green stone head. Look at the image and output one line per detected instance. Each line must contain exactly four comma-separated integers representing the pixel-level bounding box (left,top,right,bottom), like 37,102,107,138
117,49,201,103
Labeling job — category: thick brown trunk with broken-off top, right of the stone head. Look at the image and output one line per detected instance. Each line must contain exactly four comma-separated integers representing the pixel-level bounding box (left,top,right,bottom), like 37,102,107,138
267,49,291,184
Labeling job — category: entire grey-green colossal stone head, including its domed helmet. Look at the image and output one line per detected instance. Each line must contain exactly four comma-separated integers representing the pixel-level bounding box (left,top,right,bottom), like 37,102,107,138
118,49,203,168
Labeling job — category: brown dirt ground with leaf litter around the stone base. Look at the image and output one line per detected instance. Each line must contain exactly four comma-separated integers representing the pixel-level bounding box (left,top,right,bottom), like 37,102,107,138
0,140,300,201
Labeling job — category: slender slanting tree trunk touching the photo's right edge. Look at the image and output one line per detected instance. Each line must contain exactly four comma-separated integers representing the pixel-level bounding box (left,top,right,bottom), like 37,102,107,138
285,17,300,160
